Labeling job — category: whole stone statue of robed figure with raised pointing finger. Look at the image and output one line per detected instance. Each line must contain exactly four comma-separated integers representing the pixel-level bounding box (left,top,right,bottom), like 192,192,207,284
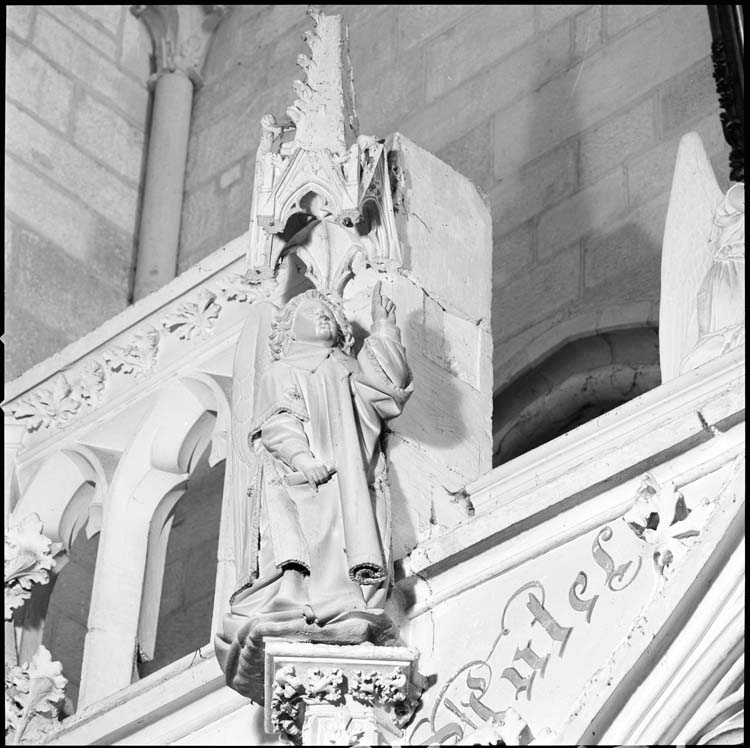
216,282,412,698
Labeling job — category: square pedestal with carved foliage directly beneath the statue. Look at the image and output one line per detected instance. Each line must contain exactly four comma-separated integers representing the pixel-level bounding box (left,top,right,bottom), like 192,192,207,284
265,639,422,745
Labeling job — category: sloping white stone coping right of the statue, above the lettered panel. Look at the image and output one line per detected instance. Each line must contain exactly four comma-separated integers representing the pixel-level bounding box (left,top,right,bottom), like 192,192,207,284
400,346,745,578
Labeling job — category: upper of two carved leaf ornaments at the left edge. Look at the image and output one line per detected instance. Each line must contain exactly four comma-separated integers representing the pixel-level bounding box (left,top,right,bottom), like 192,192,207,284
5,514,60,621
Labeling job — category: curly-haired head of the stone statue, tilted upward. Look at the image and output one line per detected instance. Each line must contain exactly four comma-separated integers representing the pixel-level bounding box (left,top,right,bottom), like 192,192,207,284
271,291,354,360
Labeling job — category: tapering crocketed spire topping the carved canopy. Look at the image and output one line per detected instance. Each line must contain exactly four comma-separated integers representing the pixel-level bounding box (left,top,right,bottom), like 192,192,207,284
287,6,359,156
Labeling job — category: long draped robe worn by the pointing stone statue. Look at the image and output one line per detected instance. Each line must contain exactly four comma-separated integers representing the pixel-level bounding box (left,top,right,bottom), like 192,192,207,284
222,320,412,640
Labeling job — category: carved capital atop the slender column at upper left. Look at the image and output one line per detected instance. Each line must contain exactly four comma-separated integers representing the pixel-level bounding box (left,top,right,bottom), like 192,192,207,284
130,5,230,86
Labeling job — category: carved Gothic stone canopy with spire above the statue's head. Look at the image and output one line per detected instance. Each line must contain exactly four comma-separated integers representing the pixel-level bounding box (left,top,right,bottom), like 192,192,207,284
248,8,401,296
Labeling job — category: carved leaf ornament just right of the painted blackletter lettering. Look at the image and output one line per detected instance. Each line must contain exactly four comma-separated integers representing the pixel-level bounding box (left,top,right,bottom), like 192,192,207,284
623,474,713,577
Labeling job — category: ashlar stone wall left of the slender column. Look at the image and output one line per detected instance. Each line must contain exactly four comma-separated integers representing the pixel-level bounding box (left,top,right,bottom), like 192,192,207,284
4,5,151,380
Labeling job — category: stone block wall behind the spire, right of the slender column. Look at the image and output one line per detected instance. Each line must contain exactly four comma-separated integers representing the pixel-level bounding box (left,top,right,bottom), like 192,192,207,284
175,5,728,404
